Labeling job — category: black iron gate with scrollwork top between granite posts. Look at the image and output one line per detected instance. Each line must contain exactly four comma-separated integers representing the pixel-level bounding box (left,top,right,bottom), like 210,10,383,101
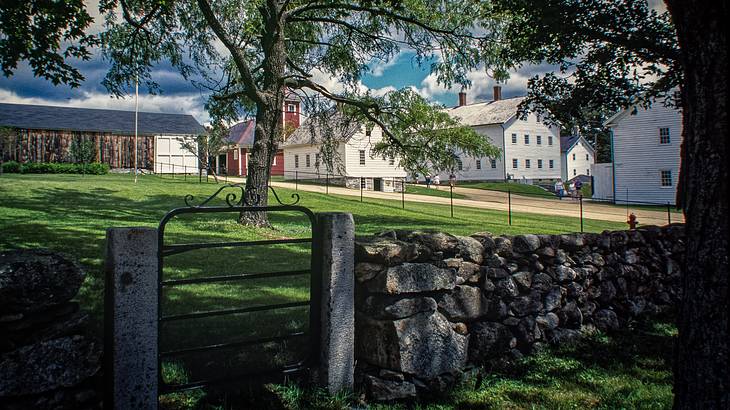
158,184,322,394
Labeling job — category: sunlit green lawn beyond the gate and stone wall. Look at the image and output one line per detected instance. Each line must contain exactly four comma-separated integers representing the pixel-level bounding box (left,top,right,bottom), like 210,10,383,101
0,174,623,408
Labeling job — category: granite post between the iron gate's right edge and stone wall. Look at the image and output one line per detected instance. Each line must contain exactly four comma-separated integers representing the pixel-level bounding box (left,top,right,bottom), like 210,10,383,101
315,212,355,394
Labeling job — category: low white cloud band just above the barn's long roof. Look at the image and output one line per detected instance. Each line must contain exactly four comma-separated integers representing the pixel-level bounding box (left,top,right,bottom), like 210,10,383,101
0,89,209,124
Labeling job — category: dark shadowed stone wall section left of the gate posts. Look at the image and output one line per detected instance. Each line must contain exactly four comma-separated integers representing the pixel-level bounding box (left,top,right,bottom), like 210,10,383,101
0,250,102,410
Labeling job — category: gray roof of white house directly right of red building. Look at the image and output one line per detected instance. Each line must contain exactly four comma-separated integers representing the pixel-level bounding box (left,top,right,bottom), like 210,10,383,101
283,114,360,147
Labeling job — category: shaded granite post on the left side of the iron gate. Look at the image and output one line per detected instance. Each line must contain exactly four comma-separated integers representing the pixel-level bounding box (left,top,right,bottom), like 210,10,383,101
104,228,158,409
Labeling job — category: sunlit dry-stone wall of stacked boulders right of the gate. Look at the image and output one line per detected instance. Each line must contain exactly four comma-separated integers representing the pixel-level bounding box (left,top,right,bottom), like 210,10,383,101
355,225,684,400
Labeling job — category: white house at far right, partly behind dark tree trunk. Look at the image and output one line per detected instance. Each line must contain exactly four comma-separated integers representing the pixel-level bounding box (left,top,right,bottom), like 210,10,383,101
604,102,682,204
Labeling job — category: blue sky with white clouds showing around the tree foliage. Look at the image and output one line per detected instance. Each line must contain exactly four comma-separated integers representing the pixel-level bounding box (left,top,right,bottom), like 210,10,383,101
0,1,552,124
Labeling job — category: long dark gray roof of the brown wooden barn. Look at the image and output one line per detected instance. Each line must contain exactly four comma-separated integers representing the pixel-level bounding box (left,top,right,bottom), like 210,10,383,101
0,103,205,135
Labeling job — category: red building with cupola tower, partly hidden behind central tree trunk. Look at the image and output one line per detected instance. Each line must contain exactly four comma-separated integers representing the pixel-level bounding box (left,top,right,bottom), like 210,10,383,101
217,93,301,176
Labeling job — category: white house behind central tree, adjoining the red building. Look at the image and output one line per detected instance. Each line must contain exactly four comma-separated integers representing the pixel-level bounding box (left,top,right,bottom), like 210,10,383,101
283,116,406,192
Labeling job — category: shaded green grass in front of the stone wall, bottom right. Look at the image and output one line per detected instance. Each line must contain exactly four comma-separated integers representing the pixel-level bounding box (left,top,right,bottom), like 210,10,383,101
258,321,677,410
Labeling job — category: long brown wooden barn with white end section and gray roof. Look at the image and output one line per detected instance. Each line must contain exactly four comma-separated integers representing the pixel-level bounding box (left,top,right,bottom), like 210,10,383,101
0,103,205,173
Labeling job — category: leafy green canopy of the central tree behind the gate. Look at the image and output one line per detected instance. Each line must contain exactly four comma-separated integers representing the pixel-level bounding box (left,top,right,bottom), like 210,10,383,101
101,0,498,178
